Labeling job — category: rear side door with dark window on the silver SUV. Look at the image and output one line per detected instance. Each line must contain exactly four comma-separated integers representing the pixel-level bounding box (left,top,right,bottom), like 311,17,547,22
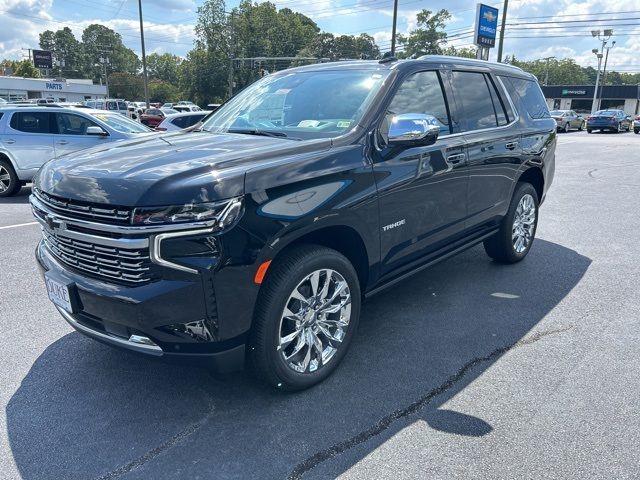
2,111,55,170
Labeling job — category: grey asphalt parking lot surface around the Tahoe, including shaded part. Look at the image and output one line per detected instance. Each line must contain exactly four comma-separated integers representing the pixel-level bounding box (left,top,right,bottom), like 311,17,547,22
0,132,640,480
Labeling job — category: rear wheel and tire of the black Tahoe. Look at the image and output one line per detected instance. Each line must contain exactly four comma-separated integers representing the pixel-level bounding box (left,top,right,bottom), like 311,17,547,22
484,182,538,263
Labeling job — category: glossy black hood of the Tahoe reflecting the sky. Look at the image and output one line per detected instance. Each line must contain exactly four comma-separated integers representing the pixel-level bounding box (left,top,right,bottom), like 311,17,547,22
34,132,331,206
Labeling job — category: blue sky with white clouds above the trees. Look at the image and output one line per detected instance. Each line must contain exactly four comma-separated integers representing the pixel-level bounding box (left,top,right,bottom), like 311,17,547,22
0,0,640,72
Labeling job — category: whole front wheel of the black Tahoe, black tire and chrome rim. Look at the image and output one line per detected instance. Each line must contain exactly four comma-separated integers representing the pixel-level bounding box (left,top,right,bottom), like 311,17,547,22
250,245,360,391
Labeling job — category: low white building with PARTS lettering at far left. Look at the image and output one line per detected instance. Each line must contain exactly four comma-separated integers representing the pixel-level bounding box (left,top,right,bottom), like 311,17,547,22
0,76,107,102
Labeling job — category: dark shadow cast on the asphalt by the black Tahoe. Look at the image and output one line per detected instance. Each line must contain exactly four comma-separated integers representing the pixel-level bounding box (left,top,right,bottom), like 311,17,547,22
6,239,591,480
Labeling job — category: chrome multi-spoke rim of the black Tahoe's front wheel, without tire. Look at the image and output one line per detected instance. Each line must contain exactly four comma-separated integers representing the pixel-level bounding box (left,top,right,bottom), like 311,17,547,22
276,269,351,373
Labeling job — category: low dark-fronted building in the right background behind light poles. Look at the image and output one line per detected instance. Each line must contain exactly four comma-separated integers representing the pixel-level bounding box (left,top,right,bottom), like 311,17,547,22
542,85,640,115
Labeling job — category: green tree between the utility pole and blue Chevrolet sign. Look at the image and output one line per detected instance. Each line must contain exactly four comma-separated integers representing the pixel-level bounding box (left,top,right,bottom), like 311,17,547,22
398,9,451,58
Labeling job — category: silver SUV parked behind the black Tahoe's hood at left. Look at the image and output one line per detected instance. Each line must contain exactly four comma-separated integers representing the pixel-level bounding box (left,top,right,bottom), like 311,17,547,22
0,105,155,197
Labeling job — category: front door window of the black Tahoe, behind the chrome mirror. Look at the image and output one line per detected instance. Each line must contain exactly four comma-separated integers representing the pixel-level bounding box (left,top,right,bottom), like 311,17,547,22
388,71,450,133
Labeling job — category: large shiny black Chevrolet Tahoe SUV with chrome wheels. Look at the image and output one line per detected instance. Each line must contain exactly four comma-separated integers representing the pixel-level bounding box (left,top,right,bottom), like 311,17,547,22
31,56,556,390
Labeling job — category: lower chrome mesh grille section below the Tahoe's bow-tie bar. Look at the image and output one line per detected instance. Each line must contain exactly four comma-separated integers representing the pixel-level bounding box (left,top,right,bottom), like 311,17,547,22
43,229,153,284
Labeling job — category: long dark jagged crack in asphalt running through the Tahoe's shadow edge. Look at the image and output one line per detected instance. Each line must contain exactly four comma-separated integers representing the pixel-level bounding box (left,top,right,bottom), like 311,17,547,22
287,325,573,480
